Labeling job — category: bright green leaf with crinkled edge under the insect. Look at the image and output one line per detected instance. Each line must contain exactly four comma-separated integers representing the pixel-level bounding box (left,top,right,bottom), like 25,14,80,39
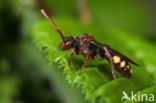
31,17,156,103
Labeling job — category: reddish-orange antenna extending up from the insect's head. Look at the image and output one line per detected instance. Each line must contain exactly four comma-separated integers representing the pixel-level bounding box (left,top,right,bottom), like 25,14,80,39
41,9,64,41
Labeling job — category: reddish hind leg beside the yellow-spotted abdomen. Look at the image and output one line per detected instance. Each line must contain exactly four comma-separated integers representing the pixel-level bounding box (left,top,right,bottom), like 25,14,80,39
103,47,119,83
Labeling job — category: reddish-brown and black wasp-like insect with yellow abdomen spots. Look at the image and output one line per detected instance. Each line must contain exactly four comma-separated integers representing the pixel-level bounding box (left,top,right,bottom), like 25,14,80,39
41,9,138,83
